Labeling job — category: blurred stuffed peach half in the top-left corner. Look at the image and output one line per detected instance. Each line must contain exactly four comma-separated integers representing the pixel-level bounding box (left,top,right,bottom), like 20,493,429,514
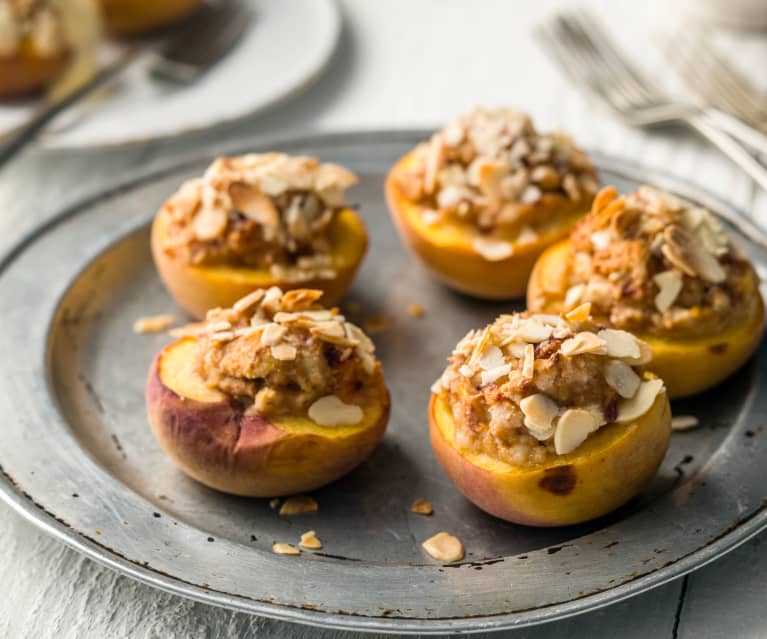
0,0,71,97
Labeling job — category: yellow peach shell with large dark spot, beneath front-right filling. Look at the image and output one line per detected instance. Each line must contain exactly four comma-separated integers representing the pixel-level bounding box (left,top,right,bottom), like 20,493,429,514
429,393,671,526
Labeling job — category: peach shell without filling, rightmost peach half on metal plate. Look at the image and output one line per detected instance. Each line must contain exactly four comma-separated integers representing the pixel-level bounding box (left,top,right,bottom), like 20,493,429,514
527,240,764,399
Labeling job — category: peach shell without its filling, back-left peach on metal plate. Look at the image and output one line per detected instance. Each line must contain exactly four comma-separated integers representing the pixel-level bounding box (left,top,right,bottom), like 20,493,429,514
152,209,368,319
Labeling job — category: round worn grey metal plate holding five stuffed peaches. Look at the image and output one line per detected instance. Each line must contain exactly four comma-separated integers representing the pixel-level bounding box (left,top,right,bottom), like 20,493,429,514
0,132,767,633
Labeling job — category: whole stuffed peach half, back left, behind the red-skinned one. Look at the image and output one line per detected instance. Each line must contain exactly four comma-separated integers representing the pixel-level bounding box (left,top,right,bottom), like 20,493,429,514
152,153,367,318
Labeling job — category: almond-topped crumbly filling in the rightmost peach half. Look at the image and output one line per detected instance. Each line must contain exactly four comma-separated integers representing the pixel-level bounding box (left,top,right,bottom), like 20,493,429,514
536,186,758,336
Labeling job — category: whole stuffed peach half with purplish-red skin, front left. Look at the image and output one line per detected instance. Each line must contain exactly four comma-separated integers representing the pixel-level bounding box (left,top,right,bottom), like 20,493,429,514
147,288,389,497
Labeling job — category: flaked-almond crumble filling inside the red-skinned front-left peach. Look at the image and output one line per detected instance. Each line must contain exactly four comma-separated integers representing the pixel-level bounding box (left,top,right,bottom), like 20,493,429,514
197,287,381,418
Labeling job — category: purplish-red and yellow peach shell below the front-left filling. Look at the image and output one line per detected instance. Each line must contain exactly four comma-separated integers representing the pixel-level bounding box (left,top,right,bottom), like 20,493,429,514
146,338,390,497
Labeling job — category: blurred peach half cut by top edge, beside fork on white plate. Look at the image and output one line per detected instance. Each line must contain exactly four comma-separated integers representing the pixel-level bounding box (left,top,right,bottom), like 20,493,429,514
99,0,202,37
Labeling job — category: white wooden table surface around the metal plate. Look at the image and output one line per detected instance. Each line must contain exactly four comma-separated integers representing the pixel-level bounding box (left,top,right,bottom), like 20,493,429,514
0,0,767,639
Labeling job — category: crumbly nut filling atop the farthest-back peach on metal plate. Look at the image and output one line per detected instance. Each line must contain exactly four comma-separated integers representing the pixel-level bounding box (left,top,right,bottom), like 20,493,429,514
399,108,597,241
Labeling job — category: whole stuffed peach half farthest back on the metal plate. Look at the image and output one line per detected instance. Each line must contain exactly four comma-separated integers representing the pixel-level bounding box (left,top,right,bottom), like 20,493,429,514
385,109,597,299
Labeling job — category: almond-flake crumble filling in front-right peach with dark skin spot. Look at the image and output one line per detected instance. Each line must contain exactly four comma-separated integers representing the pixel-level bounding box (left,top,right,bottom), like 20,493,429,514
432,305,664,466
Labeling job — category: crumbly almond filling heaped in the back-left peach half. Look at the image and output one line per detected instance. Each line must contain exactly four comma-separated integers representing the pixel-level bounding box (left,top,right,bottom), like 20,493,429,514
159,153,357,280
